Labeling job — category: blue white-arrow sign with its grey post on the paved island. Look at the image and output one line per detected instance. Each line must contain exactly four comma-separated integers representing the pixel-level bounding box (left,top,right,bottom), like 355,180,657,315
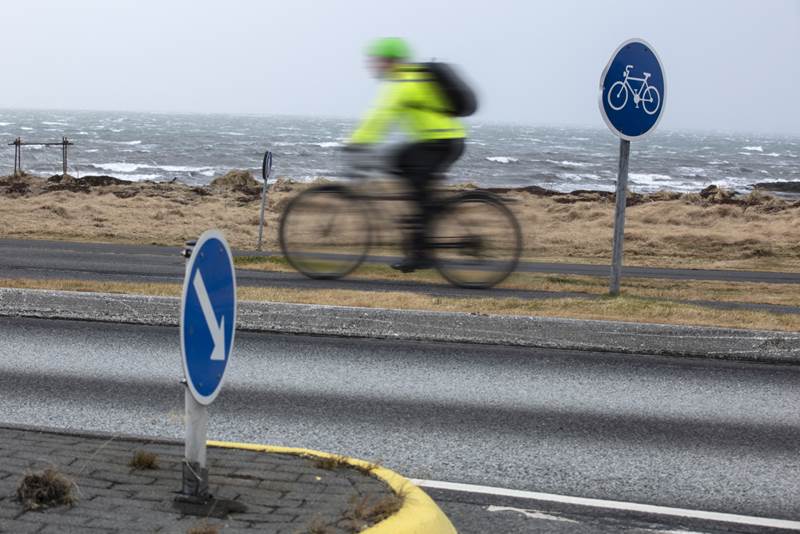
175,230,241,517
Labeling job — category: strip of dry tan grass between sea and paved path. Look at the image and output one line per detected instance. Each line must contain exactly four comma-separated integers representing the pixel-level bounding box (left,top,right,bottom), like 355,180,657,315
0,170,800,271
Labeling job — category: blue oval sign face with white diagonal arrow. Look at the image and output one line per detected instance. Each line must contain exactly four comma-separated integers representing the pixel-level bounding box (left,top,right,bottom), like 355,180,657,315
180,230,236,405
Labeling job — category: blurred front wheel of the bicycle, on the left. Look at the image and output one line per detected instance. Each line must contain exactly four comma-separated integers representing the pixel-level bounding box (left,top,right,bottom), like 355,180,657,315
279,185,371,280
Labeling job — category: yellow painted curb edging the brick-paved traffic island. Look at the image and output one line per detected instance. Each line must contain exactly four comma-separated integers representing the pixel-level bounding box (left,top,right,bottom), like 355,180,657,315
207,440,457,534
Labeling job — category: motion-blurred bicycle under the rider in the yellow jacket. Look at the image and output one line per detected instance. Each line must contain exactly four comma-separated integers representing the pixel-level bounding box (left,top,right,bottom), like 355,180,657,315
278,171,522,289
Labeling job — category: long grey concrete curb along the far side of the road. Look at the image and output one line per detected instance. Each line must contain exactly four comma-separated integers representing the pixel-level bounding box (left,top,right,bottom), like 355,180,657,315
0,288,800,364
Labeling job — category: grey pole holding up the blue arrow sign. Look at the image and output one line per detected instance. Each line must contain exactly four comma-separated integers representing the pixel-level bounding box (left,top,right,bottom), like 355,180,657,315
181,241,211,501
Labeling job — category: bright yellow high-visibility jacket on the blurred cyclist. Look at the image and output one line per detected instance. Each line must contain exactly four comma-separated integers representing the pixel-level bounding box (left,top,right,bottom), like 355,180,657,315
350,64,467,144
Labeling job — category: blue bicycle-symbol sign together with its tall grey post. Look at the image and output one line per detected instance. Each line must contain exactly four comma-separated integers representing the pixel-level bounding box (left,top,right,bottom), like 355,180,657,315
600,39,667,296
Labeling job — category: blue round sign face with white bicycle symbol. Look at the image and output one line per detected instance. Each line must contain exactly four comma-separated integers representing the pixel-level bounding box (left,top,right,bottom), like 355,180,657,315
600,39,667,141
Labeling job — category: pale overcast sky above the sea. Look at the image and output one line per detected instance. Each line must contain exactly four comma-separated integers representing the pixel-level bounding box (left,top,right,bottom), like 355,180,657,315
0,0,800,134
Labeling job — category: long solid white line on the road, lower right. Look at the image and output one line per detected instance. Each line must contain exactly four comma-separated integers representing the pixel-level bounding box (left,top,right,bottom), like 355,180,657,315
411,479,800,531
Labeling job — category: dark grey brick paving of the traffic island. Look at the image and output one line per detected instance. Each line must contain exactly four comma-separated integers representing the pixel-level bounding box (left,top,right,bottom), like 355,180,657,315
0,427,393,534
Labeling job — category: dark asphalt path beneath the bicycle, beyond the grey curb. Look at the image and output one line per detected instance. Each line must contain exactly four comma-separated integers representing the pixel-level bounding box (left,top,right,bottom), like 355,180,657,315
0,239,800,313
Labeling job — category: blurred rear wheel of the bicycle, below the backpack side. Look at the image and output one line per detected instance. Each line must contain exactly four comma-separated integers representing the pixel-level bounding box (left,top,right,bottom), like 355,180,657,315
430,191,522,289
